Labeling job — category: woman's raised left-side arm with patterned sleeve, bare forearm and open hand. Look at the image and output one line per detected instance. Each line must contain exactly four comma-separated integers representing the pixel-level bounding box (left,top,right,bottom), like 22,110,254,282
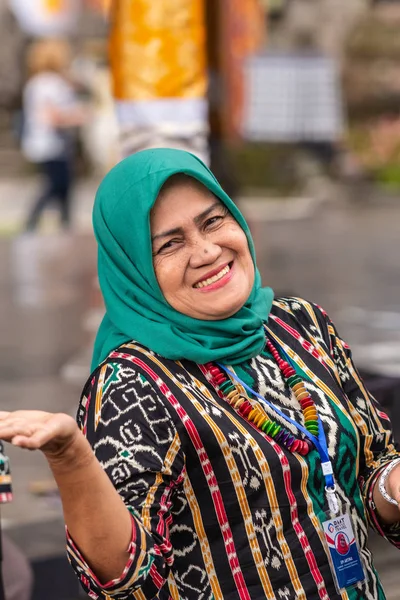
0,361,185,600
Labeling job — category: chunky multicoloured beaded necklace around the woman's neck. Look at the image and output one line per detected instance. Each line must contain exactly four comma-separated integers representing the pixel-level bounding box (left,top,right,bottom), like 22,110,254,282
200,340,318,456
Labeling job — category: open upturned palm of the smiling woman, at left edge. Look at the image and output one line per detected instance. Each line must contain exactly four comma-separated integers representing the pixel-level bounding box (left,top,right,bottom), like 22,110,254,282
0,410,83,459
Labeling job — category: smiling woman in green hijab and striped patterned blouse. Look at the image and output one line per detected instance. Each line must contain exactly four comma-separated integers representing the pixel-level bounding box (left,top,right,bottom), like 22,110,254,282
0,149,400,600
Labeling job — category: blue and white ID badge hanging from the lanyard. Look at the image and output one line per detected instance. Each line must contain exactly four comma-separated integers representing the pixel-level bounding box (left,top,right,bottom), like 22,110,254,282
322,514,365,590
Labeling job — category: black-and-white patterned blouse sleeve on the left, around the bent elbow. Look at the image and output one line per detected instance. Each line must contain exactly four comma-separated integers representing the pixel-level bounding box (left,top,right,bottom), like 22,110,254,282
67,362,185,600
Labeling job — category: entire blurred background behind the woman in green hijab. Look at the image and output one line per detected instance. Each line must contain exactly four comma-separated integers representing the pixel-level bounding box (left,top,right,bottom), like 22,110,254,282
0,0,400,600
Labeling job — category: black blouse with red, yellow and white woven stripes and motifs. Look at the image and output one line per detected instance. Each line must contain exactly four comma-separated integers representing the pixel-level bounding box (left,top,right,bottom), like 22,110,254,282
68,298,400,600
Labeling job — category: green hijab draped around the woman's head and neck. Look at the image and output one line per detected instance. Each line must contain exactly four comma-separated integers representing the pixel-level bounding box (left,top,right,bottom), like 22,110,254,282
92,148,273,369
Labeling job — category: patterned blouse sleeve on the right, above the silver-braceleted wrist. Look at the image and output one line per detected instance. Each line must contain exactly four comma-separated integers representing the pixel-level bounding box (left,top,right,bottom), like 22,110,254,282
318,308,400,548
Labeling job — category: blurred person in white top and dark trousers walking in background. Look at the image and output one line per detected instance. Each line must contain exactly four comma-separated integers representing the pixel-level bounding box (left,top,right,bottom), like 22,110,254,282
22,39,86,231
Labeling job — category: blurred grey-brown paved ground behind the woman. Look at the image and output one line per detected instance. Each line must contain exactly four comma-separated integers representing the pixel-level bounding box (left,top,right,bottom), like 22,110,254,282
0,173,400,600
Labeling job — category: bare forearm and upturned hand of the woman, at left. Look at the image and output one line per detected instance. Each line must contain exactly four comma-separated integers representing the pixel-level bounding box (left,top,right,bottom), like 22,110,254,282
0,411,132,582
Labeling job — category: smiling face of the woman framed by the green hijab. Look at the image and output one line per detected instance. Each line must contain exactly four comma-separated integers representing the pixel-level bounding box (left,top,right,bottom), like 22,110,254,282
150,180,254,321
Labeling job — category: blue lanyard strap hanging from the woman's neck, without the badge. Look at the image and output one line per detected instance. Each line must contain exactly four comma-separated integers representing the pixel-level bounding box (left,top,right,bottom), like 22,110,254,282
217,363,336,492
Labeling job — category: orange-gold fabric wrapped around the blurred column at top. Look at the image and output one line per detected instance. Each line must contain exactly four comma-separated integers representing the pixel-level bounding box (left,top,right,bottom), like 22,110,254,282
110,0,207,101
